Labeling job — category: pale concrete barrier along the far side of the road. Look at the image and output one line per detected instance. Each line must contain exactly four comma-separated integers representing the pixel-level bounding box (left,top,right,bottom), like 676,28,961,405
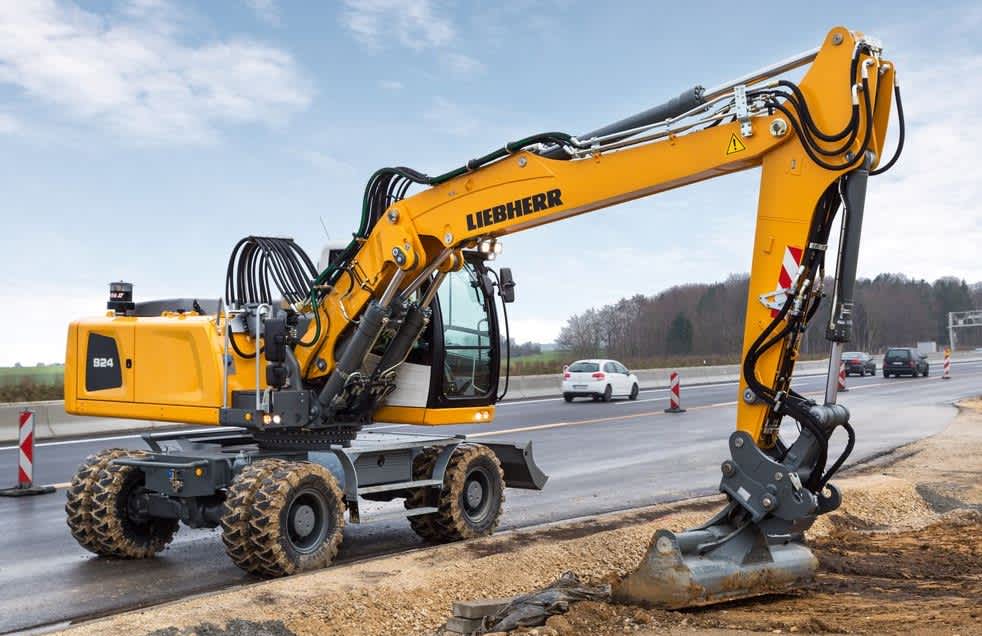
0,351,982,442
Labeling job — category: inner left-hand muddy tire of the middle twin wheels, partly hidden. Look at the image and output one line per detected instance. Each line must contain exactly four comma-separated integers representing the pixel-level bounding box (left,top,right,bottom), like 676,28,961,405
221,459,285,573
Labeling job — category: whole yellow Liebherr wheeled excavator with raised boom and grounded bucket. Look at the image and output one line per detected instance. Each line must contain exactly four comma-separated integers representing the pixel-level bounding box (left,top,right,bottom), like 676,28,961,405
65,27,903,608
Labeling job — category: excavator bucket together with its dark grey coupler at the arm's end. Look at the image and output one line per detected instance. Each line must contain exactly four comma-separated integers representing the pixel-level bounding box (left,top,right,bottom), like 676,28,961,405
613,420,848,609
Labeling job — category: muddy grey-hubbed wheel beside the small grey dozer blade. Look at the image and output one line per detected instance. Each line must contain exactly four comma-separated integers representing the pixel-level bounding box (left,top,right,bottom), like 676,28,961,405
407,444,505,543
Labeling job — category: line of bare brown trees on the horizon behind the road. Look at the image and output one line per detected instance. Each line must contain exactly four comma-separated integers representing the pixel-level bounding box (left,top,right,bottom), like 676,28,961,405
556,274,982,363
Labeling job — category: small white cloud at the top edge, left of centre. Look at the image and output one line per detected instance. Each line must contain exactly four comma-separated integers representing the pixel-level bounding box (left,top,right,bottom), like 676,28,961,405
341,0,456,51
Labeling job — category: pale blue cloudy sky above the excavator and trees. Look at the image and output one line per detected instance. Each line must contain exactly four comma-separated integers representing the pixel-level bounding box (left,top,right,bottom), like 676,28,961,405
0,0,982,365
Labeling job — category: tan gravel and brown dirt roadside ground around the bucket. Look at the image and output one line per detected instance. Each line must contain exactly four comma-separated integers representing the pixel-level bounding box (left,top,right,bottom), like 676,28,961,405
61,400,982,636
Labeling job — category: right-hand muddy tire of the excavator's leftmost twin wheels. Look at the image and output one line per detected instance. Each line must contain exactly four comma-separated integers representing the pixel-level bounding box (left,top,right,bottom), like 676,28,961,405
85,451,179,559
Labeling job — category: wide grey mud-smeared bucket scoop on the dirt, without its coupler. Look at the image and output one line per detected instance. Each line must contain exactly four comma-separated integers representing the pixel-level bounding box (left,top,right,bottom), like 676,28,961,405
614,526,818,609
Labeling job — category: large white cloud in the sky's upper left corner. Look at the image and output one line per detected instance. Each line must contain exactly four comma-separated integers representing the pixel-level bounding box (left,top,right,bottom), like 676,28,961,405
0,0,311,143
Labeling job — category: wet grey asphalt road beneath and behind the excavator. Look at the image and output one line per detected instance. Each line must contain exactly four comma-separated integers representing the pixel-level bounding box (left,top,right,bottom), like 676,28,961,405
0,361,982,633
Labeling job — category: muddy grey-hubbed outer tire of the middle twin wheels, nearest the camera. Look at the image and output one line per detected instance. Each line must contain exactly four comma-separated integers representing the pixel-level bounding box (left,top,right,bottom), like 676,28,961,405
244,462,345,577
